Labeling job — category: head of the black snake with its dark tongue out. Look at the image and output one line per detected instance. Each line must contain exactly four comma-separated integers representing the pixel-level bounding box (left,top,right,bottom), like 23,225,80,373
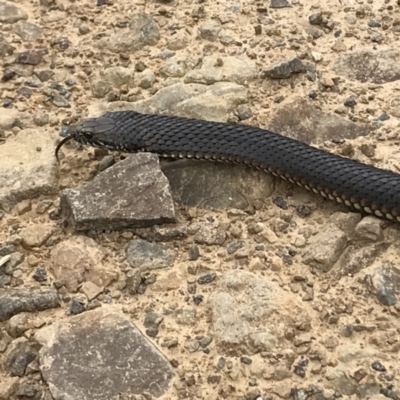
55,117,115,161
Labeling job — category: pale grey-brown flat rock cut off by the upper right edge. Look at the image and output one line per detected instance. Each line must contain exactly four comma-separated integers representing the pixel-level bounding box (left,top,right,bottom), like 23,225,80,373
334,48,400,84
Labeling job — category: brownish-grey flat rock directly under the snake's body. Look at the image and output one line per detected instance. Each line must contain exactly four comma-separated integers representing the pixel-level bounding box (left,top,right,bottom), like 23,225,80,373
162,160,274,209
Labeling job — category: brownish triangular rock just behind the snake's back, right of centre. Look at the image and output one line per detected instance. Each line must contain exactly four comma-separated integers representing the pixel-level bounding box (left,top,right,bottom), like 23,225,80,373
268,97,371,144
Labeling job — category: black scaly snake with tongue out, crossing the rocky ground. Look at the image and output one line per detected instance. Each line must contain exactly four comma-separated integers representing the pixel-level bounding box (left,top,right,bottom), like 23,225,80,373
55,110,400,222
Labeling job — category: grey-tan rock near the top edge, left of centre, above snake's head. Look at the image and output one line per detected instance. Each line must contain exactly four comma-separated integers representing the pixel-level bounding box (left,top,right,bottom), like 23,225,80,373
97,13,160,53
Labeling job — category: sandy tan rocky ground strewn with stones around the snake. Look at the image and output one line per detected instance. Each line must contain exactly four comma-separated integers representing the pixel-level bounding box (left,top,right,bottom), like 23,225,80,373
0,0,400,400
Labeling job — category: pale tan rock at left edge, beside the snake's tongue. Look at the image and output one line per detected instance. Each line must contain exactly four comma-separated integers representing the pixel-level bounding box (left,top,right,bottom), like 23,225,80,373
0,130,58,212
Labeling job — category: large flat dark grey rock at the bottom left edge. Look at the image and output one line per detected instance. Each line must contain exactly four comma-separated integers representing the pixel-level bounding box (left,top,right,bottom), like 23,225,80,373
35,308,173,400
